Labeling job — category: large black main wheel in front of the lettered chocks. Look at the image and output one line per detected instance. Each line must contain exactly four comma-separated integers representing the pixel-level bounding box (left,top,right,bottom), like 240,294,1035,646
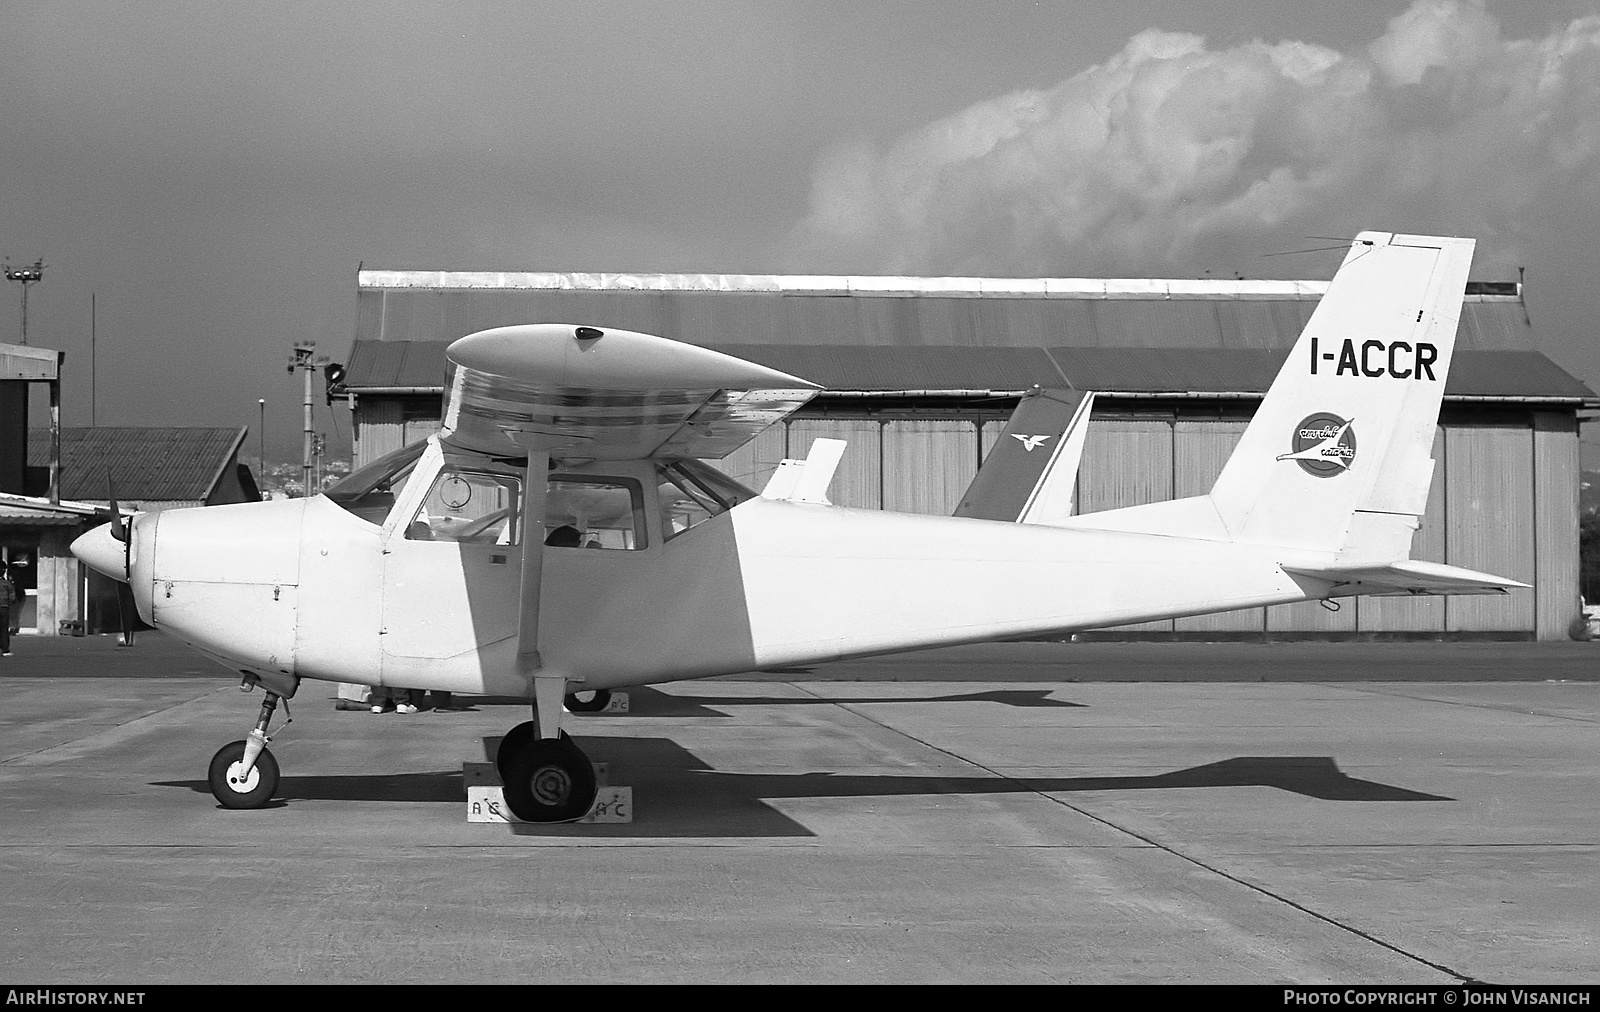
494,687,610,823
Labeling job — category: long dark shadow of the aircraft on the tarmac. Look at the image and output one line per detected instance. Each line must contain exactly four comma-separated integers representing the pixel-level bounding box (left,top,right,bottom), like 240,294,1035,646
154,737,1453,837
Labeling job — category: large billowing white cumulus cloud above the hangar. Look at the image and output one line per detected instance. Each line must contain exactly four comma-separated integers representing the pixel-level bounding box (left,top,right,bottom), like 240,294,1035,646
786,0,1600,277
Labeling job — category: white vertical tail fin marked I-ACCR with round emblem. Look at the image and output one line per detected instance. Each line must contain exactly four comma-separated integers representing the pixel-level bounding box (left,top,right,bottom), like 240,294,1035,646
1211,232,1474,559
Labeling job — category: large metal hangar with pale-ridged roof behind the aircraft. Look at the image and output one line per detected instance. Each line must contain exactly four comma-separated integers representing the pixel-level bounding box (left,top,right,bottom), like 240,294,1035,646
330,271,1600,639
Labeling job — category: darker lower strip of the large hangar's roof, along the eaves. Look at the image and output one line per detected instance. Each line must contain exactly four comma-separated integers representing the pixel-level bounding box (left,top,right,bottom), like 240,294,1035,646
334,341,1600,404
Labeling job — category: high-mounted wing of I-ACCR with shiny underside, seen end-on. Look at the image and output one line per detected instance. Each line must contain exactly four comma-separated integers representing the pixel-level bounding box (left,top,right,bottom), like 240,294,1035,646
440,323,819,460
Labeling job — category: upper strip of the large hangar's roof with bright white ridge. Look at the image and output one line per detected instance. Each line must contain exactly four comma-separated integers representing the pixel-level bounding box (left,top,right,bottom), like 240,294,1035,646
355,271,1533,349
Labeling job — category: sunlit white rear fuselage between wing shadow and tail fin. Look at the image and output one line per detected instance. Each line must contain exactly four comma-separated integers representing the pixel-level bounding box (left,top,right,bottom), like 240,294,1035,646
734,500,1307,668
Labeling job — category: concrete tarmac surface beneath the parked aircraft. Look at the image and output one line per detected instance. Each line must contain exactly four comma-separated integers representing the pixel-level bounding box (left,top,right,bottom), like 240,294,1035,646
0,634,1600,985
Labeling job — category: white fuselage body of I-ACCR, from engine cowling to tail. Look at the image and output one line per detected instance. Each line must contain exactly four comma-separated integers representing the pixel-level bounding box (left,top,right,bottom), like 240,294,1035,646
124,463,1326,695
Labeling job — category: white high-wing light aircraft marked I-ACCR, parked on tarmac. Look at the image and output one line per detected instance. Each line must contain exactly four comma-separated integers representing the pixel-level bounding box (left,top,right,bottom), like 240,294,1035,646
72,232,1525,821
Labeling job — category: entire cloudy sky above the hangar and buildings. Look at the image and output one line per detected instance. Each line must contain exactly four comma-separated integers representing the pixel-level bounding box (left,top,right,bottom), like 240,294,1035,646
0,0,1600,458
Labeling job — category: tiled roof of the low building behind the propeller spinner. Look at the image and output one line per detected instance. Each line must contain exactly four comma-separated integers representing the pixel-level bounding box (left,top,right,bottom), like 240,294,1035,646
27,428,245,503
